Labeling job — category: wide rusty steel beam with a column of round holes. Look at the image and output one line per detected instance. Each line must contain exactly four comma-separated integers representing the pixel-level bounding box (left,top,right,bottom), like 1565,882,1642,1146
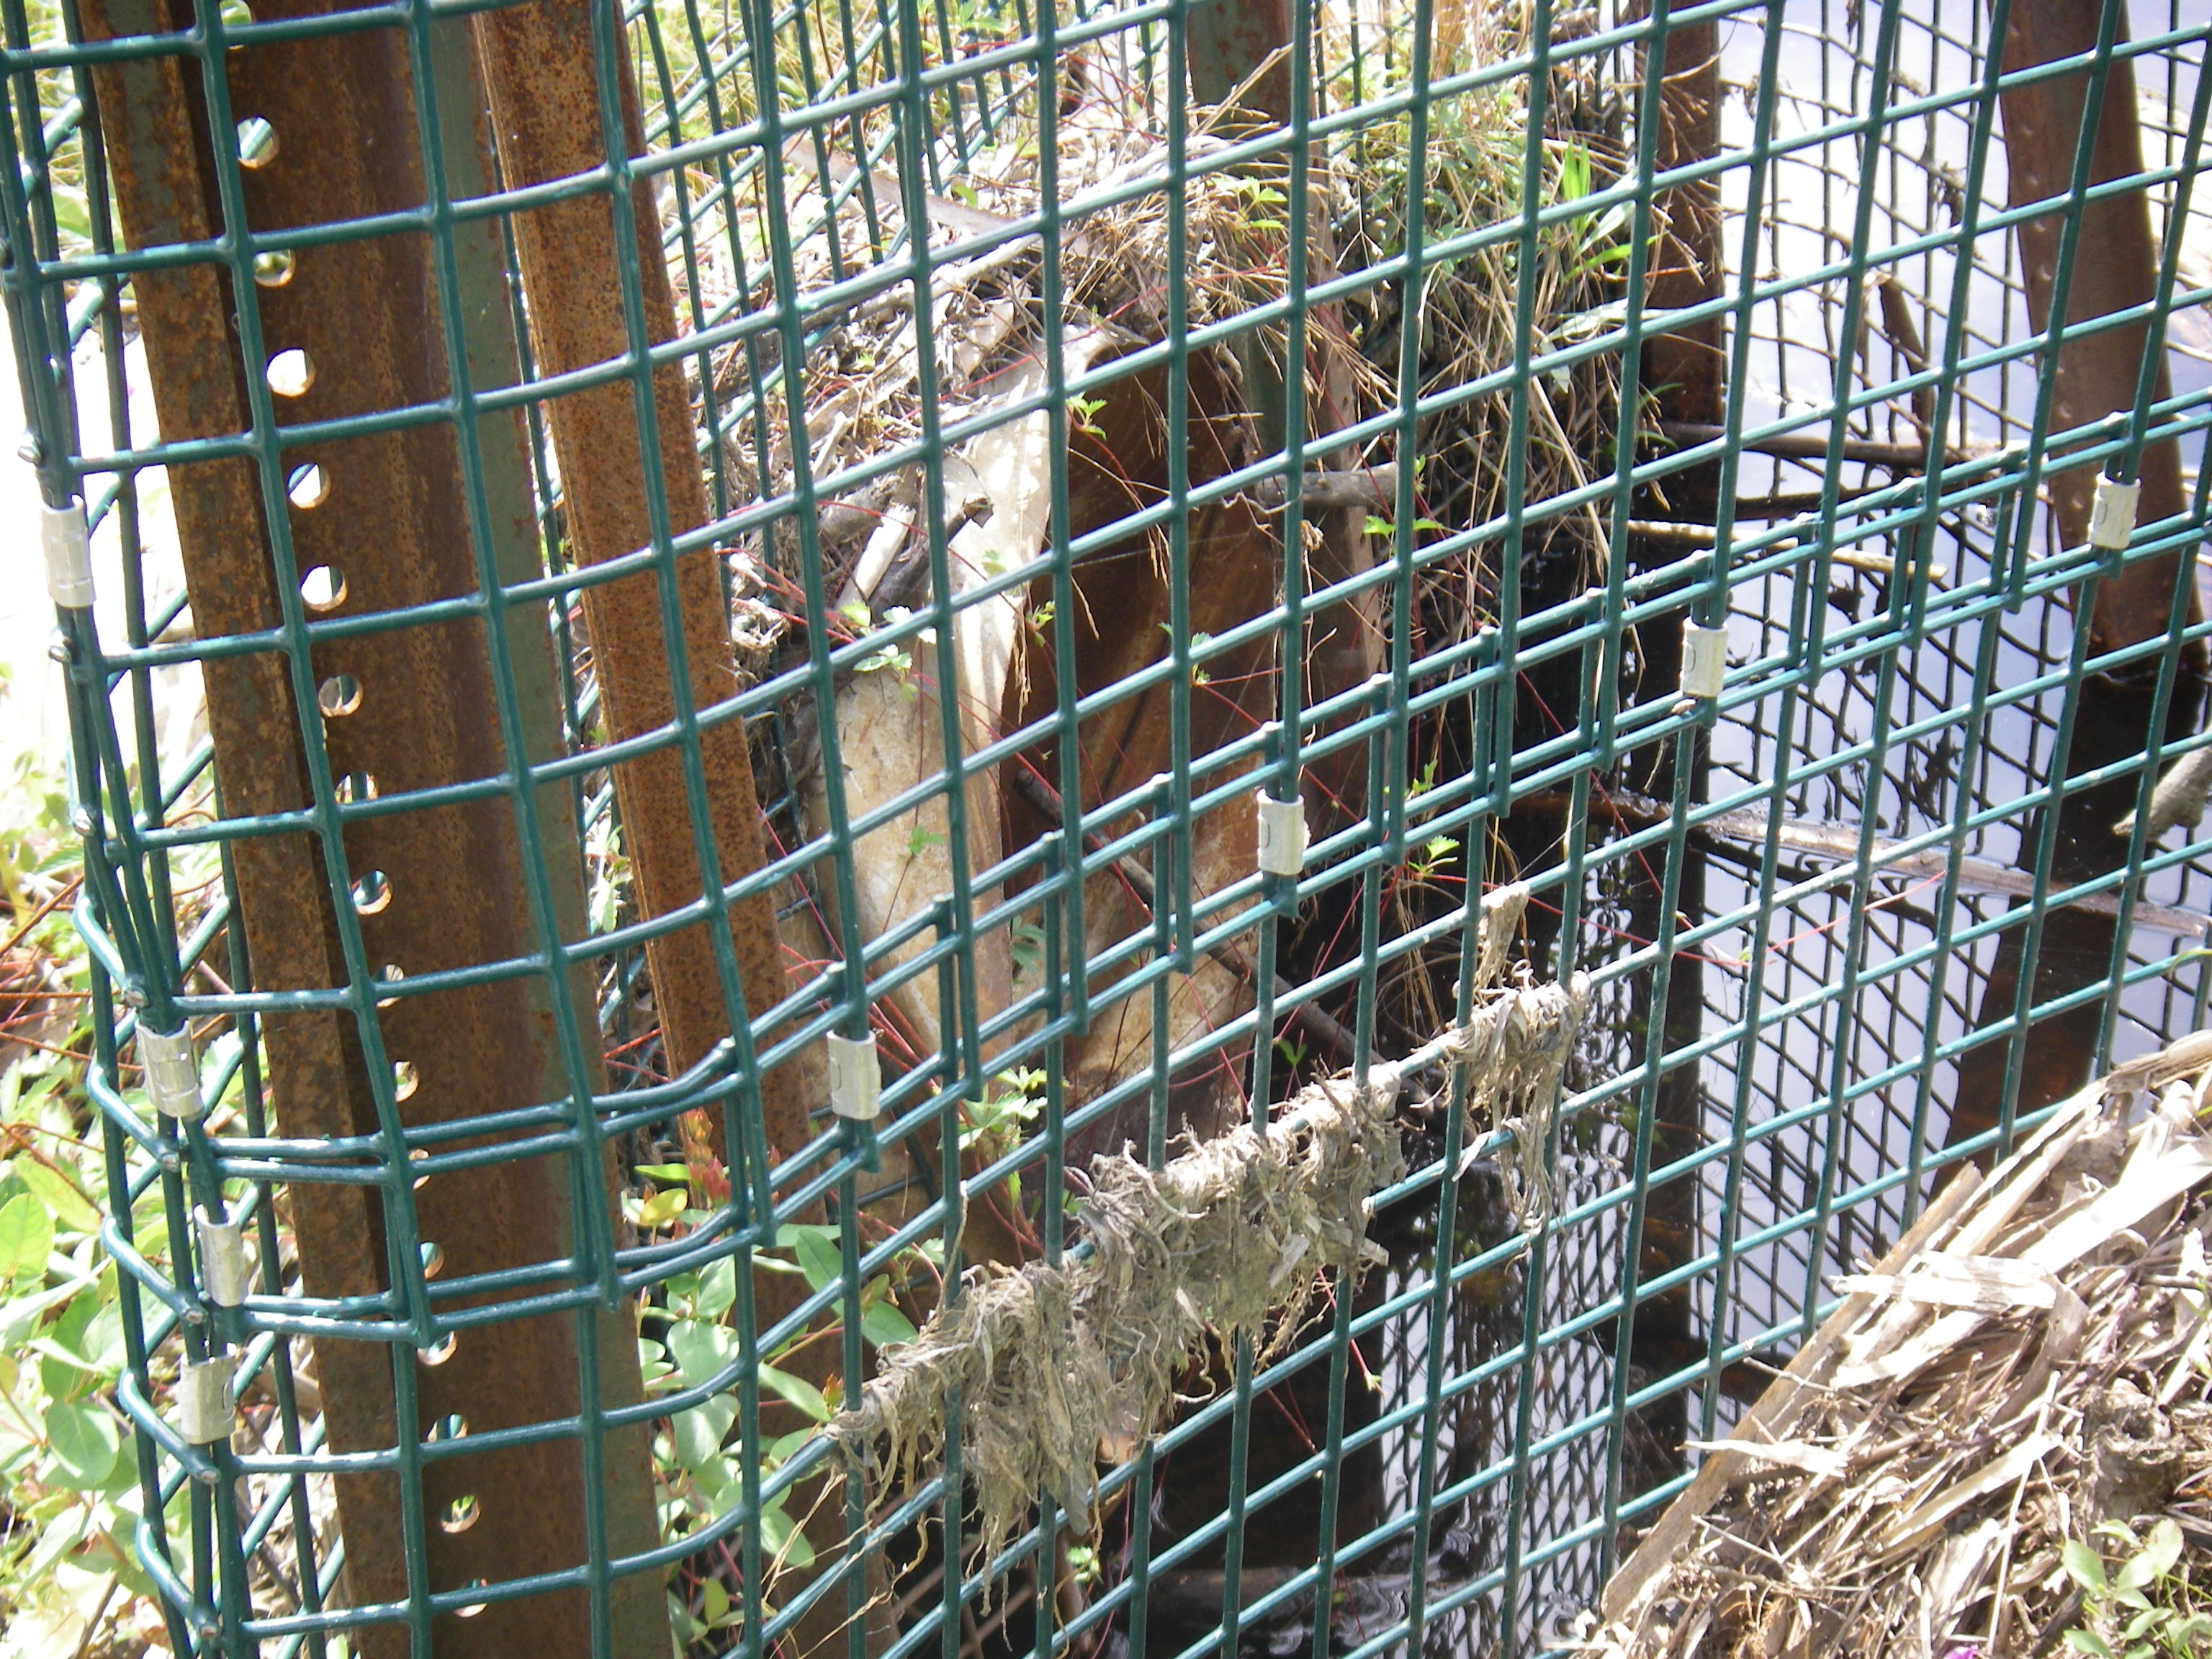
82,0,668,1657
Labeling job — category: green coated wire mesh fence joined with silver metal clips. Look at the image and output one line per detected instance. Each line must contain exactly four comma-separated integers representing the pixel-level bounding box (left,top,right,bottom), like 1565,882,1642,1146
0,0,2212,1659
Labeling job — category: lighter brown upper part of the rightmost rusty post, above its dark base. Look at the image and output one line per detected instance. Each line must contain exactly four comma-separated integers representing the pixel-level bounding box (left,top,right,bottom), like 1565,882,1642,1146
2002,0,2199,650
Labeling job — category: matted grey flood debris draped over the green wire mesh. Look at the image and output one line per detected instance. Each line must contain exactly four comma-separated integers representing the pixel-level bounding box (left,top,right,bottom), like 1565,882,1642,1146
830,885,1588,1564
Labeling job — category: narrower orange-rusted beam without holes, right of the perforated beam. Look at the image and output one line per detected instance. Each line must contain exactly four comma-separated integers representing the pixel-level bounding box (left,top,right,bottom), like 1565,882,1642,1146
475,0,809,1185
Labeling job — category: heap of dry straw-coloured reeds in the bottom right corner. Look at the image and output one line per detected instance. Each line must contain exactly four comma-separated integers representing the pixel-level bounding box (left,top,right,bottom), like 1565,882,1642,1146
1586,1033,2212,1659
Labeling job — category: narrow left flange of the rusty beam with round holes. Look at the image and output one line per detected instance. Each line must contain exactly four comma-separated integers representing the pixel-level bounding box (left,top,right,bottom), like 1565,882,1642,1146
82,16,407,1659
